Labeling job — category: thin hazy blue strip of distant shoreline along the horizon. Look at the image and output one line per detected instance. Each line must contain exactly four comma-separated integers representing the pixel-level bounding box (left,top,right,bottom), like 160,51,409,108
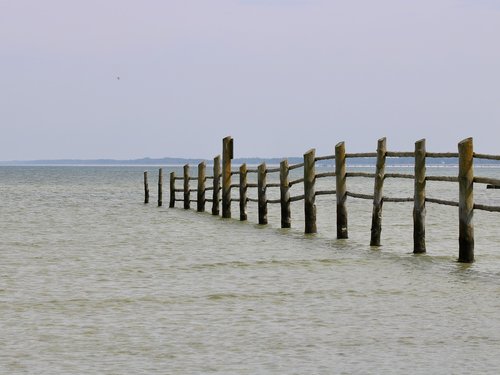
0,157,500,166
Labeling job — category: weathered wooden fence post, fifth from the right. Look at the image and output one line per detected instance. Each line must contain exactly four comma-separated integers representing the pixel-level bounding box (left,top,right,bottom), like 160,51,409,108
304,149,317,233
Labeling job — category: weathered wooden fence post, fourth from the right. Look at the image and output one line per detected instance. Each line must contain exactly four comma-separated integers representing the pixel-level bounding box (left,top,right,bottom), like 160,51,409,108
335,142,348,239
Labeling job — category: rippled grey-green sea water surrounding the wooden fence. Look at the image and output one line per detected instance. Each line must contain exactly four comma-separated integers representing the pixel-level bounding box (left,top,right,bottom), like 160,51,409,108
0,167,500,374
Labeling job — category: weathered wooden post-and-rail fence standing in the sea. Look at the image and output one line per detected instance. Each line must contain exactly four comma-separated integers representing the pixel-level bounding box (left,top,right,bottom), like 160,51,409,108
144,137,500,263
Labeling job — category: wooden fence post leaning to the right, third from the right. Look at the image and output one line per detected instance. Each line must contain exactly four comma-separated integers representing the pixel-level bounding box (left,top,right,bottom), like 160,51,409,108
370,138,387,246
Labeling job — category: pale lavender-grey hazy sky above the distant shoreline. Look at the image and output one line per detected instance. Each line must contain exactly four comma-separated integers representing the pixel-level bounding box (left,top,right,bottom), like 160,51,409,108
0,0,500,161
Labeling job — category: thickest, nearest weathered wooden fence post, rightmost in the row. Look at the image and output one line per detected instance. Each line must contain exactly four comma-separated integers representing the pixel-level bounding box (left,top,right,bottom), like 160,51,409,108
458,138,474,263
